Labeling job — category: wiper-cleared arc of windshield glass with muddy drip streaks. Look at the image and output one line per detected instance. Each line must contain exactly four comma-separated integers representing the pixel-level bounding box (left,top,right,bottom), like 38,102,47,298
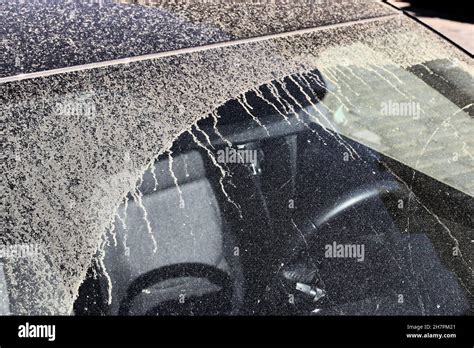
76,60,474,315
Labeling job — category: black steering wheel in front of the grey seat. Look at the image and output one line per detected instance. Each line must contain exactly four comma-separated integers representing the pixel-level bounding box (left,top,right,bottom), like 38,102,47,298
118,263,233,316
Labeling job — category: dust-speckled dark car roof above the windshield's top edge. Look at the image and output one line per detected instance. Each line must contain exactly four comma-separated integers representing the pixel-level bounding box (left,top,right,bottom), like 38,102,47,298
0,0,400,82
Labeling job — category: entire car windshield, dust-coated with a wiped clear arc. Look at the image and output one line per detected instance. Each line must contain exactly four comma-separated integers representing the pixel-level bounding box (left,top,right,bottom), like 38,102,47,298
0,0,474,315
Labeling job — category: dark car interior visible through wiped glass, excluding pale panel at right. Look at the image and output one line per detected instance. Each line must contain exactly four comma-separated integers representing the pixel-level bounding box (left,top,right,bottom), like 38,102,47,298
74,66,473,315
